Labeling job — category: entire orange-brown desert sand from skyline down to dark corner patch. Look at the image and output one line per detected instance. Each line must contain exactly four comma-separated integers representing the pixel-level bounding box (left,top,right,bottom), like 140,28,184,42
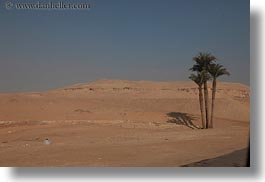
0,80,250,166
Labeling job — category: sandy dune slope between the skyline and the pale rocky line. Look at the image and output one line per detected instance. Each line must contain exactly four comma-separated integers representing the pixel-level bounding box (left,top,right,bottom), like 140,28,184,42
0,80,250,121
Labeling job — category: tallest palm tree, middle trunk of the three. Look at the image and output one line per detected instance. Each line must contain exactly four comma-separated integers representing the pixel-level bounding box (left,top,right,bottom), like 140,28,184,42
190,52,216,128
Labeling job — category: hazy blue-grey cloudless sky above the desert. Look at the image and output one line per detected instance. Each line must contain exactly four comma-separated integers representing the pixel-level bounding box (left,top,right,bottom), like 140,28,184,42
0,0,250,92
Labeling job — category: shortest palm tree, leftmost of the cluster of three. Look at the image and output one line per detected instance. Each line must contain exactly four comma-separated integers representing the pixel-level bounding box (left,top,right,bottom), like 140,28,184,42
189,73,208,129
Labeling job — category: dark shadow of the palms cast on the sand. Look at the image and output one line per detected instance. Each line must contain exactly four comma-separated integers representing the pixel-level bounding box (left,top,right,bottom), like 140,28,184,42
167,112,199,129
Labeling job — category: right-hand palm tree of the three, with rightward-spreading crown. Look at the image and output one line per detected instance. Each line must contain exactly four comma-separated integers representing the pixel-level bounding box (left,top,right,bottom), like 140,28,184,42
208,64,230,128
